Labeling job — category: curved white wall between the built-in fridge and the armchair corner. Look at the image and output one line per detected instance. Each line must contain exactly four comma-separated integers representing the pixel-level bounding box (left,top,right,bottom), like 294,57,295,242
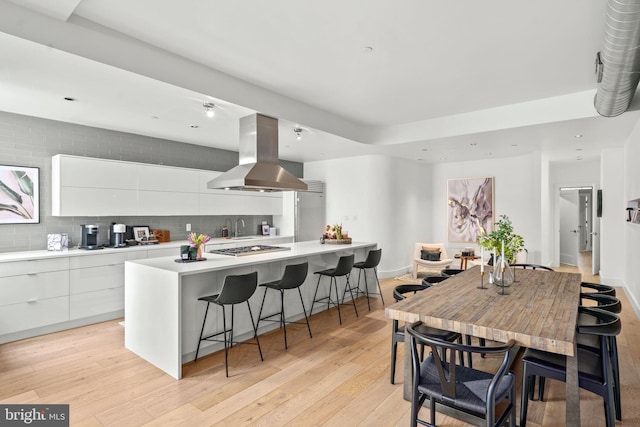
304,155,433,277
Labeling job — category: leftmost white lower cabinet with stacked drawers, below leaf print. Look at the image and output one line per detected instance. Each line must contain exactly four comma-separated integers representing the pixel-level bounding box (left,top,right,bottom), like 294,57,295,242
0,258,69,342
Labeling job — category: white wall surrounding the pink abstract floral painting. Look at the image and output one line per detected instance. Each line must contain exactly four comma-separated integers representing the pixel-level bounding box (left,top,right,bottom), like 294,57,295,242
431,154,541,263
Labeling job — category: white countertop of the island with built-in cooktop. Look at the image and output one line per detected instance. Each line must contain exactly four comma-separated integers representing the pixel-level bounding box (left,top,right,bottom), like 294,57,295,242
125,241,377,276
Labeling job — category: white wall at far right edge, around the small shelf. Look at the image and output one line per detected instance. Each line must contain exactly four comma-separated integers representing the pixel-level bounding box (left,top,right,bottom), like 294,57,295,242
621,122,640,317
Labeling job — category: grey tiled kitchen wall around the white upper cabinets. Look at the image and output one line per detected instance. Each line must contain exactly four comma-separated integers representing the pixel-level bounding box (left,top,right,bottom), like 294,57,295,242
0,112,303,252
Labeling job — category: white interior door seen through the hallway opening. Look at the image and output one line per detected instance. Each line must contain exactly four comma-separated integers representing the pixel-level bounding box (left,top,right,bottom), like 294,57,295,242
560,190,580,265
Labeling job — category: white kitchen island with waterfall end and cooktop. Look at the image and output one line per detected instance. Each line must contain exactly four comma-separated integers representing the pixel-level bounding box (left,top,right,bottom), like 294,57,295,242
125,241,376,379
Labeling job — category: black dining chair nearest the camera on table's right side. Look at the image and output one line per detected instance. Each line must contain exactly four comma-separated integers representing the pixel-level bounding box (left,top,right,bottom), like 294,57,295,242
520,306,622,427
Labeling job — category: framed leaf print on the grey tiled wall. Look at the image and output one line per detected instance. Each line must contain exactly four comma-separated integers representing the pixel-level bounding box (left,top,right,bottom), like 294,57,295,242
0,165,40,224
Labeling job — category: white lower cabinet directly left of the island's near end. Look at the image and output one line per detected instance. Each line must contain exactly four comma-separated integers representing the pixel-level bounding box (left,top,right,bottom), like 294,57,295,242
69,251,146,320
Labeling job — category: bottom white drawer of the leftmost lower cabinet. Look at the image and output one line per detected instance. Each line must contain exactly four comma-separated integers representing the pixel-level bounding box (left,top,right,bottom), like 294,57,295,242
0,296,69,335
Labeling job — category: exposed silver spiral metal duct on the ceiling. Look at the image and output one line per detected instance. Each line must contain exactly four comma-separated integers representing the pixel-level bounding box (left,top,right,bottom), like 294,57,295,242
594,0,640,117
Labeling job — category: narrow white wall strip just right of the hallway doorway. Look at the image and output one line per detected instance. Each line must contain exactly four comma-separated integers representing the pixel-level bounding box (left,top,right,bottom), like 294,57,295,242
600,148,624,285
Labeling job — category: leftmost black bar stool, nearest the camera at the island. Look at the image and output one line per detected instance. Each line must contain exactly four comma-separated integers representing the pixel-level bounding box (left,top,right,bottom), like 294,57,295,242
195,272,264,377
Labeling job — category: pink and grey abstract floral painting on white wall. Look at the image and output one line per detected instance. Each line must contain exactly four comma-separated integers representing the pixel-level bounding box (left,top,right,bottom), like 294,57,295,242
447,177,493,243
